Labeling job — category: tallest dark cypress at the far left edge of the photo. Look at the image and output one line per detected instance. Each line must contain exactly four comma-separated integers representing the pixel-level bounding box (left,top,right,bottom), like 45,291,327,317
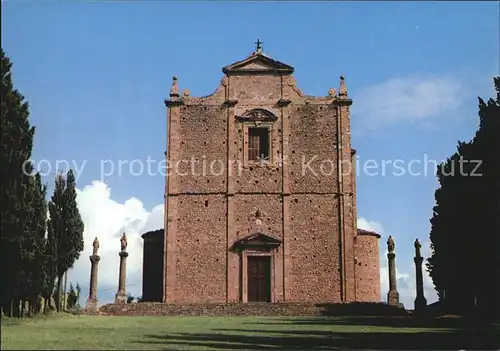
0,49,35,315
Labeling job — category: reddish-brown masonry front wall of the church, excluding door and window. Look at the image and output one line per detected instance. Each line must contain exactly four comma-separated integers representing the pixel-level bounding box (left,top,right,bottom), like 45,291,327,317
165,51,379,303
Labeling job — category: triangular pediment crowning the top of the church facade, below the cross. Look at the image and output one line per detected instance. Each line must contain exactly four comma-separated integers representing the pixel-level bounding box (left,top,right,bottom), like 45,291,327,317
222,53,294,75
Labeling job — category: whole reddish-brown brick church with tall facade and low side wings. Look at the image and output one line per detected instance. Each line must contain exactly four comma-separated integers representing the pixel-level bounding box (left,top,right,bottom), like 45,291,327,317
143,41,380,304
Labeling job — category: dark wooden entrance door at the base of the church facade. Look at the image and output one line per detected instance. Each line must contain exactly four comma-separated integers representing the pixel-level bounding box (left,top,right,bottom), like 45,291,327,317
247,256,271,302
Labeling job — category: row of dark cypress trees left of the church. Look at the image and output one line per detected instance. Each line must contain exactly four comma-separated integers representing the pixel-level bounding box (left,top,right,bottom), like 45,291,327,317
0,49,84,317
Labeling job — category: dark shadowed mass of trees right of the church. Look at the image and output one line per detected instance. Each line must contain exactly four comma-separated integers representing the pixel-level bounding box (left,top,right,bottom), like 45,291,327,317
427,77,500,318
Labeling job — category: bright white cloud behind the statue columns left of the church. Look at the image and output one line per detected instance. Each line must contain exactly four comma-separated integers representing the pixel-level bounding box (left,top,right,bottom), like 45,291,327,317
68,181,163,304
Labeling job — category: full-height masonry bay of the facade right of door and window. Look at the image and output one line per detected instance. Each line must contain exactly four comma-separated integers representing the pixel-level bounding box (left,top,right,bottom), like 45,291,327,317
285,104,341,302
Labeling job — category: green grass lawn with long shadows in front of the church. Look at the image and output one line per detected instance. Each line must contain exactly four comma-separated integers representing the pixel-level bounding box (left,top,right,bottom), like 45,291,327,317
2,315,500,350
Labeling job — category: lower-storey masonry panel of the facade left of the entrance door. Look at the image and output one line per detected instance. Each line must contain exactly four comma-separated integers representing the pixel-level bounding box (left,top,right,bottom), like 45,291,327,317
173,195,226,302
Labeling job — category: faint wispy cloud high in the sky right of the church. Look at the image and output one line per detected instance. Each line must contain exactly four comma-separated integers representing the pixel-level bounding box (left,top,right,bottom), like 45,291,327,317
353,75,465,129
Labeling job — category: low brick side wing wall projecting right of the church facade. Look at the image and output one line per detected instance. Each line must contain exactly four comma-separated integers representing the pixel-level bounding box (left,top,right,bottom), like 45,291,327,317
355,233,380,302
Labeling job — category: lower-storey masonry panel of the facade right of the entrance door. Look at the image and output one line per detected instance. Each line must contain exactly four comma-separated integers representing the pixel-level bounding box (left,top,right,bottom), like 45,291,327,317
285,194,340,302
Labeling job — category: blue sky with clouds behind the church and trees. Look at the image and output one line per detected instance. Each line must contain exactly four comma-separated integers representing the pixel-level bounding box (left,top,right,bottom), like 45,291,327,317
2,0,500,304
